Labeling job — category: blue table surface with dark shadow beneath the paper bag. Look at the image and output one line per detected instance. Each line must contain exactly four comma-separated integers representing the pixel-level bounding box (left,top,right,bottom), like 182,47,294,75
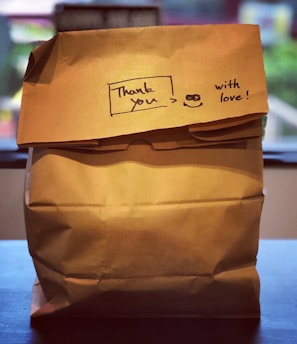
0,240,297,344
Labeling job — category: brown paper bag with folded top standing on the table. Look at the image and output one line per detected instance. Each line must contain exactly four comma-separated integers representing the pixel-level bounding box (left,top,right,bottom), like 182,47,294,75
18,25,267,317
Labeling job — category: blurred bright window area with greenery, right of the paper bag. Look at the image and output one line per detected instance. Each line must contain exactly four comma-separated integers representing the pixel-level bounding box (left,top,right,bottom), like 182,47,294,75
238,0,297,158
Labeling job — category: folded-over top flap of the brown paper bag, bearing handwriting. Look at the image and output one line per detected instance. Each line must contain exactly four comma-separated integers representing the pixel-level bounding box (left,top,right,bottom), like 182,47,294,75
17,24,268,146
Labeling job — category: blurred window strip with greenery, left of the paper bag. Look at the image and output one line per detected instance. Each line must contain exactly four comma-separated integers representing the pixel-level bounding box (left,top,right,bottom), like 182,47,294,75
0,14,54,150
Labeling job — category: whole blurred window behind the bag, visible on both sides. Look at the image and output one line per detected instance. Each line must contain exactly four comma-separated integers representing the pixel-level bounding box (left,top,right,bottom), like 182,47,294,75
0,0,297,162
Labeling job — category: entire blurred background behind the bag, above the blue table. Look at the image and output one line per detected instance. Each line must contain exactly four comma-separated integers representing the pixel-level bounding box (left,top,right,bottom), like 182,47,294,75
0,0,297,239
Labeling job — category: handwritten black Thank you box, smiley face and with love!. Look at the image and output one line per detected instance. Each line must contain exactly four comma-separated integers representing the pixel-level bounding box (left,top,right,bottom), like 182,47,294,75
108,76,249,116
